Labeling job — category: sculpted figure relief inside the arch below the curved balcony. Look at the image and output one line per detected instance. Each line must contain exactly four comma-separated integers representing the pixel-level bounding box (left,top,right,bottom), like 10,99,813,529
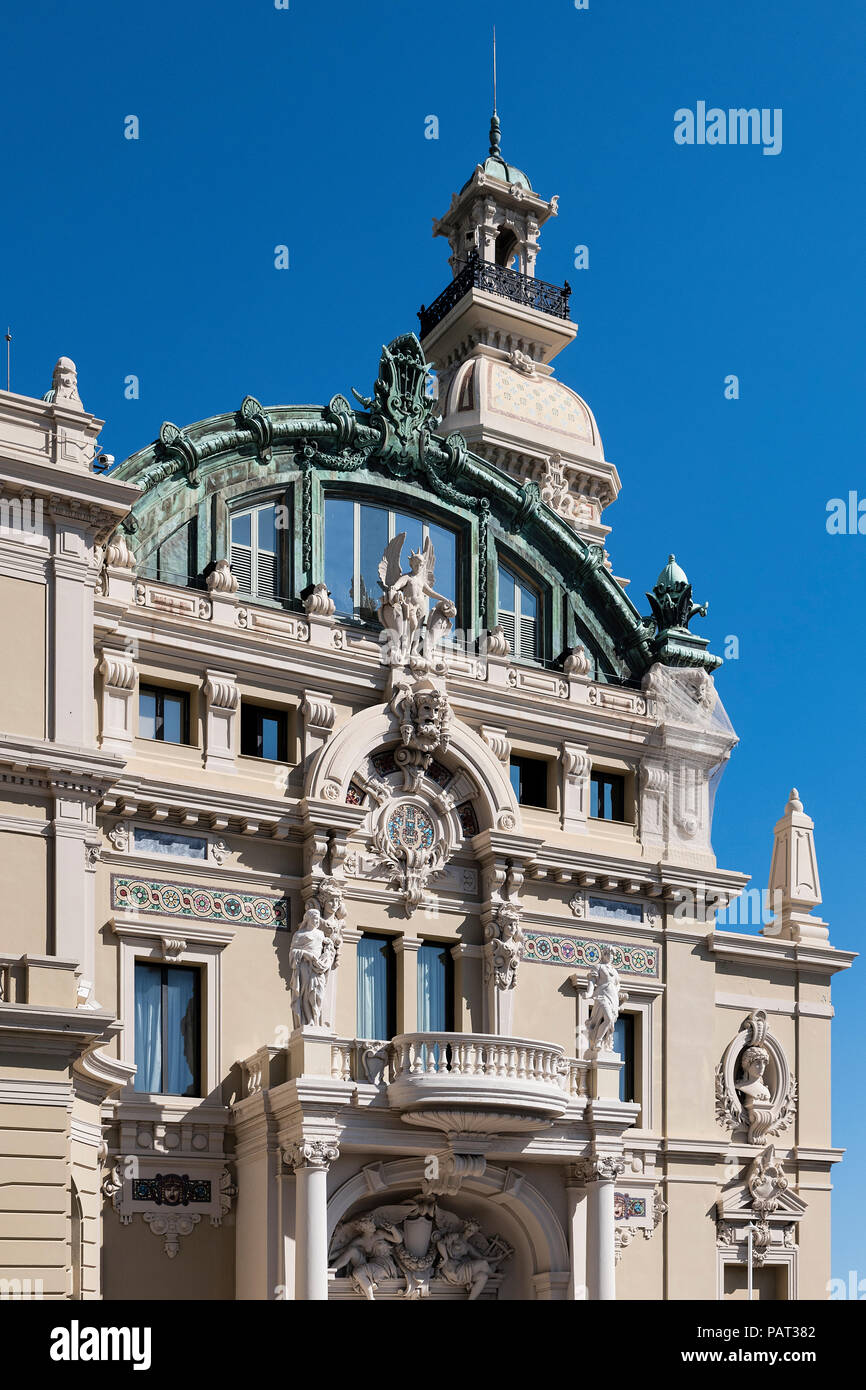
329,1194,514,1302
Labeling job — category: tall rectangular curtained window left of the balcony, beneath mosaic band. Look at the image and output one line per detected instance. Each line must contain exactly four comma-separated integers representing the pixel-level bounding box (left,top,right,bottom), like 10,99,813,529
135,960,202,1095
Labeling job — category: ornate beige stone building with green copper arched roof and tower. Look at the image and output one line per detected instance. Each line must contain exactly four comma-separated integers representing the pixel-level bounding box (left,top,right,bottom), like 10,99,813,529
0,120,853,1300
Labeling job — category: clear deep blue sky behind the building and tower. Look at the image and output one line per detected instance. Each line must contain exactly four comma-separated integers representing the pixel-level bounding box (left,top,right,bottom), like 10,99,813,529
0,0,866,1277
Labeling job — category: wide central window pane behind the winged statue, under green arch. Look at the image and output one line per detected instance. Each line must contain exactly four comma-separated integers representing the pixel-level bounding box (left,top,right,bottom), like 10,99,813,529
325,498,459,624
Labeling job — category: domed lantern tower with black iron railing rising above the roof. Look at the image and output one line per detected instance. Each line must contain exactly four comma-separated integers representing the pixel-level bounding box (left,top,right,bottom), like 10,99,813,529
418,103,620,545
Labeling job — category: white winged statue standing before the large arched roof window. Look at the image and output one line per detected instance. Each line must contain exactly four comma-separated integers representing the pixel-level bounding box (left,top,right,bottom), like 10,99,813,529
378,531,457,670
